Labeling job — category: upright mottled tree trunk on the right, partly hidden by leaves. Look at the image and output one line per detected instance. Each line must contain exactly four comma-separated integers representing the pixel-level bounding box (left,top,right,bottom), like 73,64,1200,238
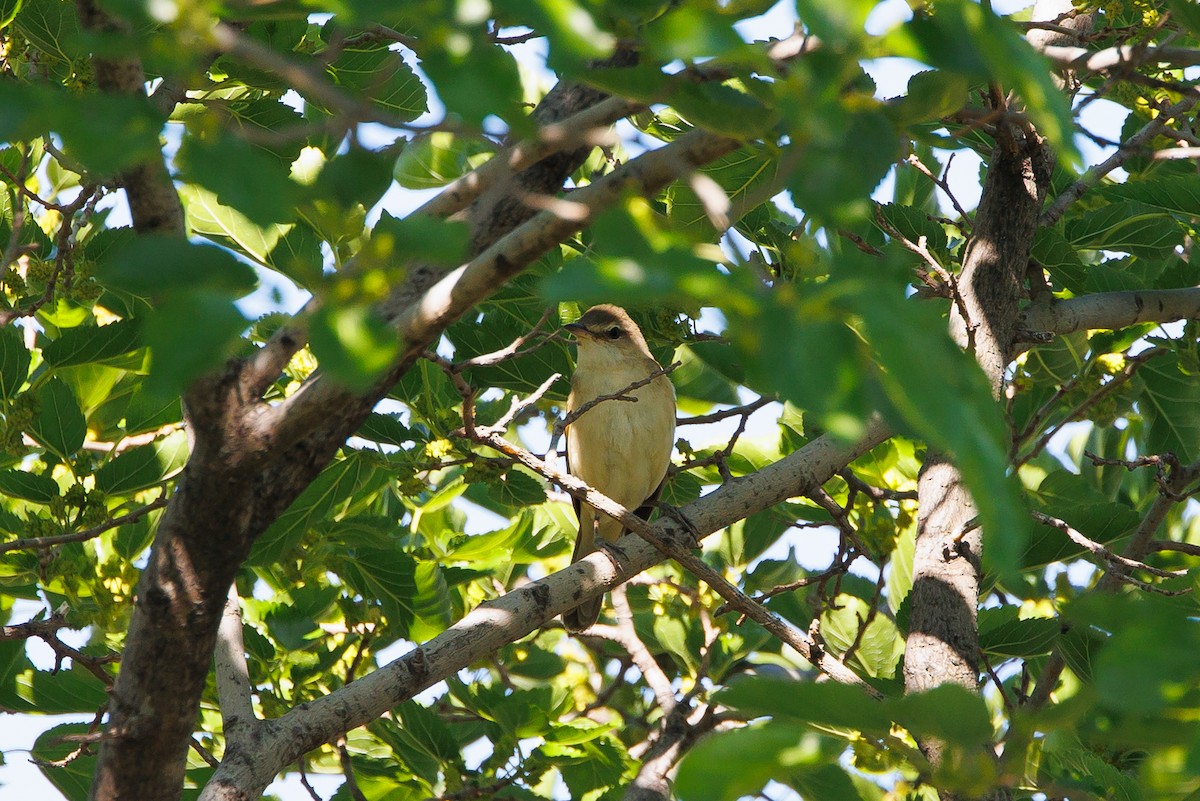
905,115,1052,797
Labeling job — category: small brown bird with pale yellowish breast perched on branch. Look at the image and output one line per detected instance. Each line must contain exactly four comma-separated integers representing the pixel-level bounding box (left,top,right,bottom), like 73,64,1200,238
563,303,676,631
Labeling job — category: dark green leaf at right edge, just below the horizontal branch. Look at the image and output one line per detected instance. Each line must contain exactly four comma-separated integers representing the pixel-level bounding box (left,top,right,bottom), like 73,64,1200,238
1138,353,1200,463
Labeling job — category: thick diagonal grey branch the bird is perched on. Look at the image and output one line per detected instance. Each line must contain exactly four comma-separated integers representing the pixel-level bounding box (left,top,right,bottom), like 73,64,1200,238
202,423,889,801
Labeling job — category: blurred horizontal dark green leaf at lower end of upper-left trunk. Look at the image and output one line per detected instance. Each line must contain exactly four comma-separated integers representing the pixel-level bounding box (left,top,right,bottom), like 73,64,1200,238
96,236,258,298
